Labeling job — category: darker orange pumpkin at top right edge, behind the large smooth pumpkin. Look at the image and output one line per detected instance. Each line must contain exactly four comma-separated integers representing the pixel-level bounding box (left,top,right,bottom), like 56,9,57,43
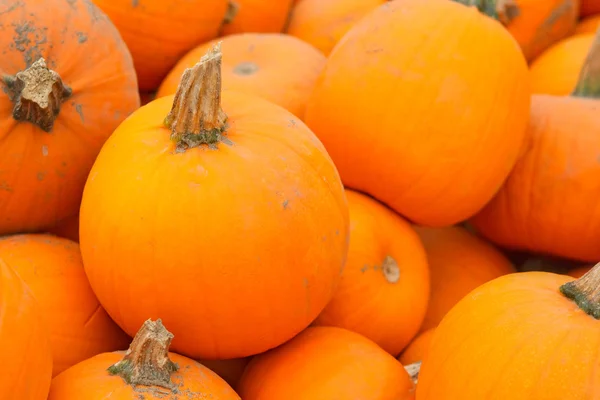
455,0,580,60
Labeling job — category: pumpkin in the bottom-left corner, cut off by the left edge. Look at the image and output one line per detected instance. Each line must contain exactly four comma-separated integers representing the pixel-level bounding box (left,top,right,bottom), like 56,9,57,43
0,259,52,400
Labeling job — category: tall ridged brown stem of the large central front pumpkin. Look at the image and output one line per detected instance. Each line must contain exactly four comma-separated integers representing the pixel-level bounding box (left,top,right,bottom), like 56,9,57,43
165,42,227,152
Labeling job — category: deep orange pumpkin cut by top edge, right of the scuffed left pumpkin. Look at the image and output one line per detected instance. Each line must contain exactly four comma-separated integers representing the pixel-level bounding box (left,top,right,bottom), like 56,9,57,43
94,0,228,91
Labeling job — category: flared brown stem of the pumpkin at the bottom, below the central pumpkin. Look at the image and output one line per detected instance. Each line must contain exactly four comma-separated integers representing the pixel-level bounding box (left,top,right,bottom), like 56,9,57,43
108,319,179,392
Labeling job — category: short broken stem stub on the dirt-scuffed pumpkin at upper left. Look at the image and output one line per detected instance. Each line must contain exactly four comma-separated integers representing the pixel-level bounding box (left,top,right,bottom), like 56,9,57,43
3,58,72,132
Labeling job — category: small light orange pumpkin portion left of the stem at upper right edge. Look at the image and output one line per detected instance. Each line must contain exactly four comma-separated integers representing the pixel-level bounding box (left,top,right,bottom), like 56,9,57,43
530,33,594,96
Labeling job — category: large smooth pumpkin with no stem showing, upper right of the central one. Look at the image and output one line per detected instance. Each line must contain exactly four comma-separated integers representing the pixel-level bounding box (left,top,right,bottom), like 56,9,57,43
305,0,529,226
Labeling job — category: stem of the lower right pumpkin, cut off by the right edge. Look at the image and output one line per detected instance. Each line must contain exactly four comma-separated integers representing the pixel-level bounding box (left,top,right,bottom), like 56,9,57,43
560,263,600,319
